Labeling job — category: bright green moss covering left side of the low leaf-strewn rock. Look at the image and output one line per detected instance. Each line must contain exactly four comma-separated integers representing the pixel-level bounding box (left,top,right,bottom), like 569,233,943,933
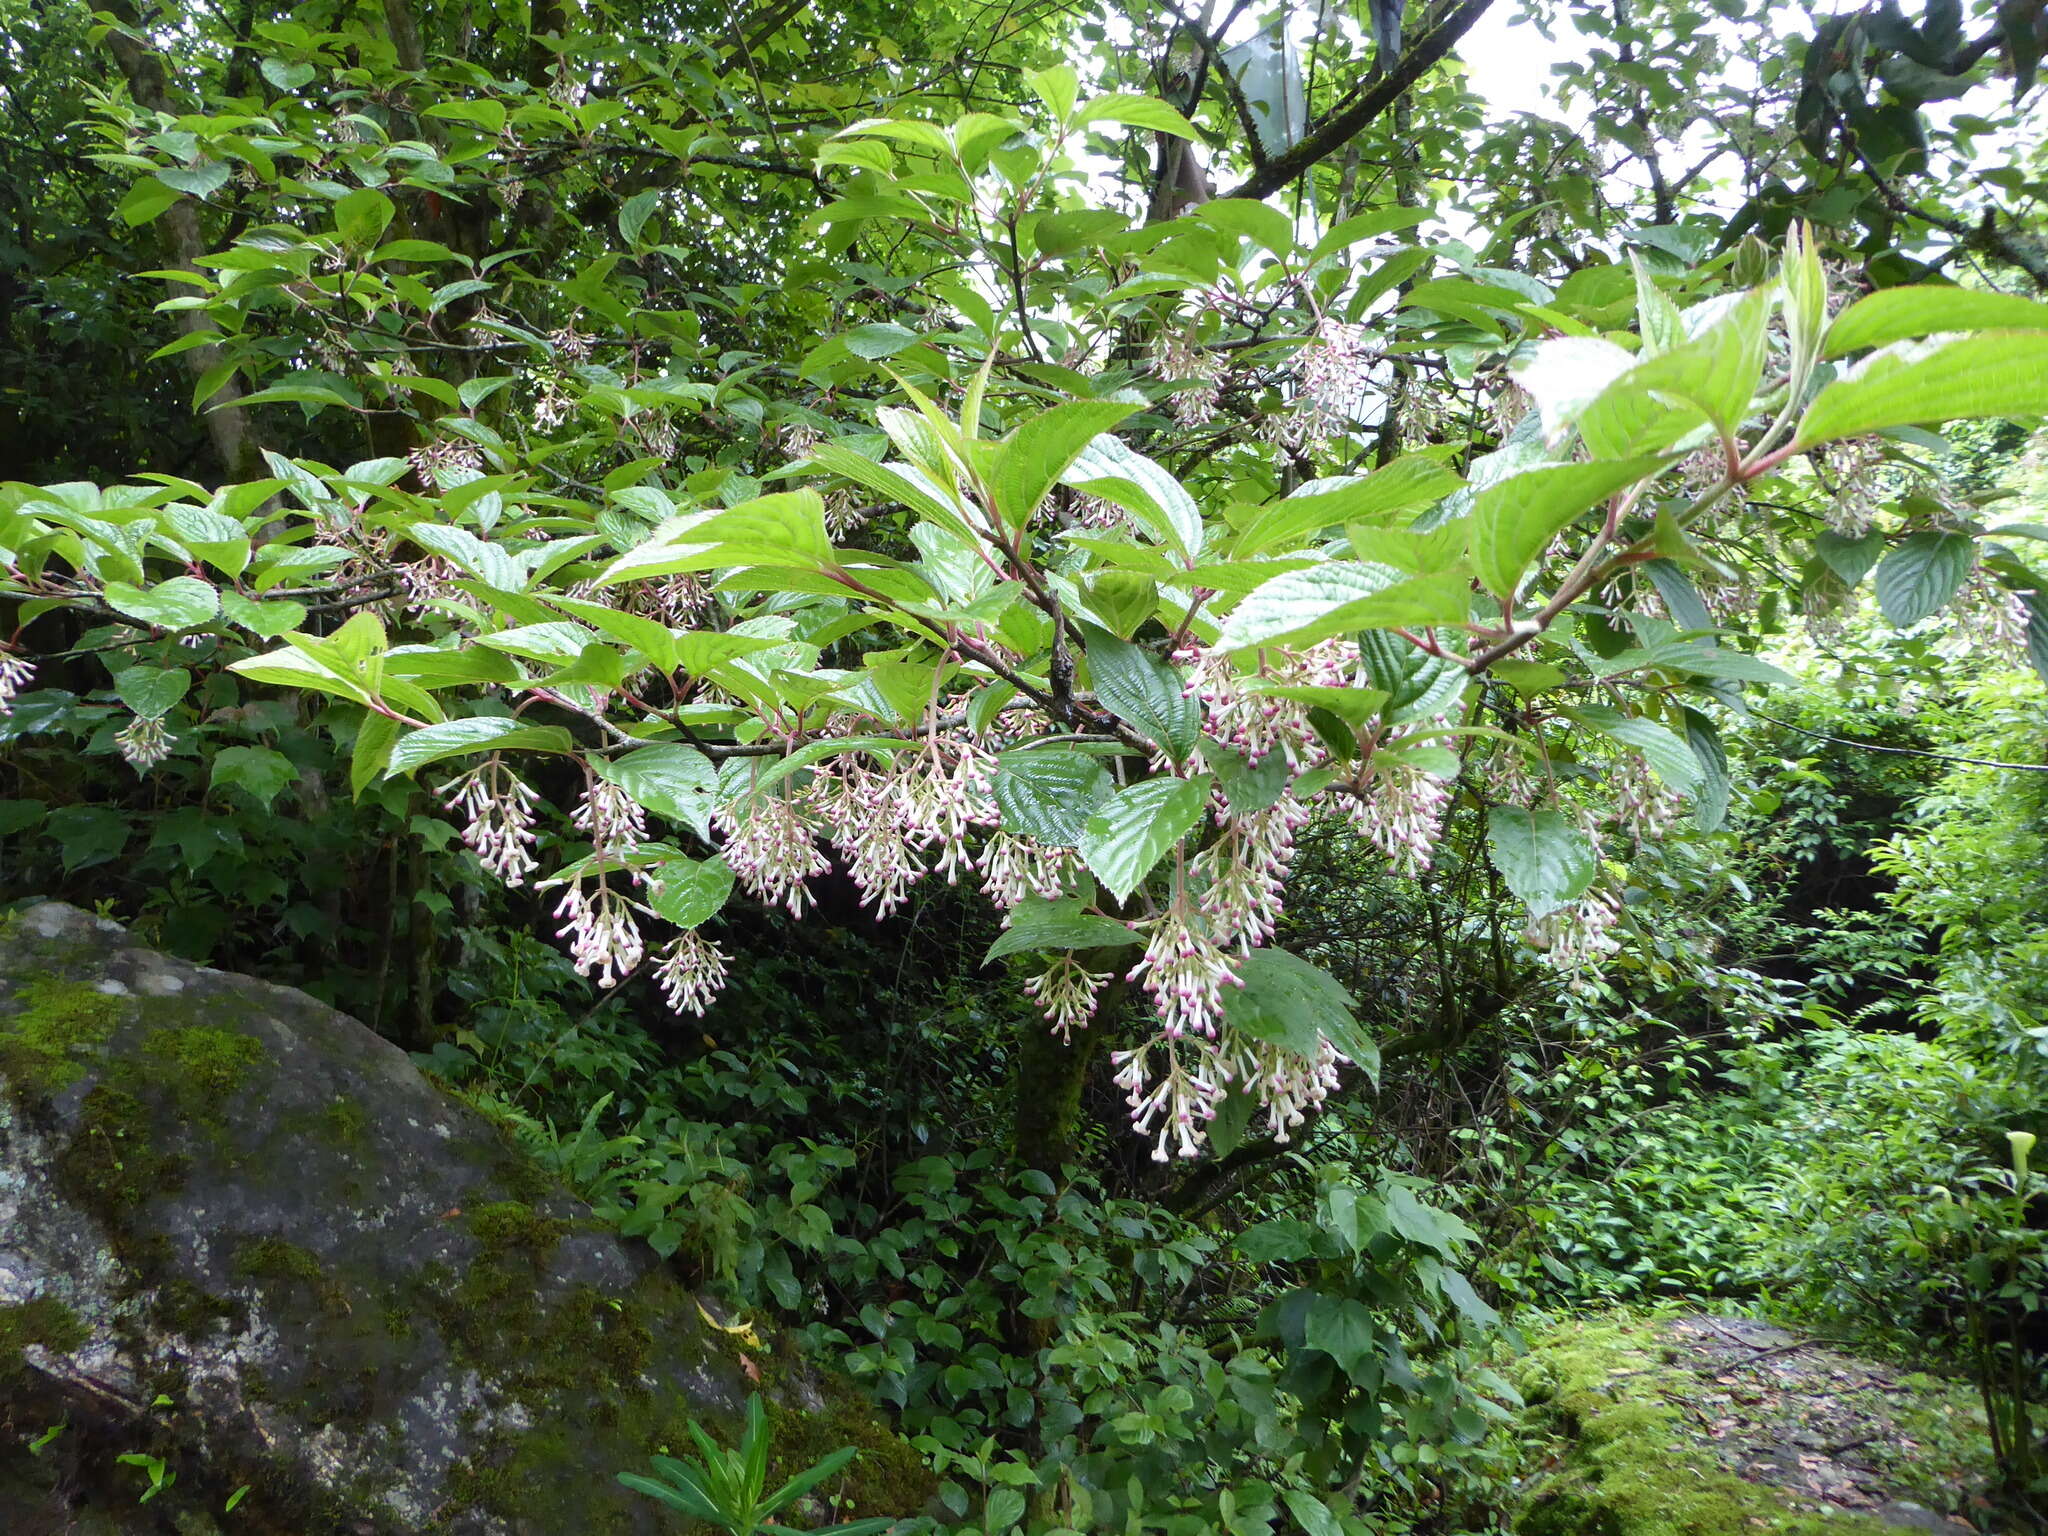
1513,1319,1884,1536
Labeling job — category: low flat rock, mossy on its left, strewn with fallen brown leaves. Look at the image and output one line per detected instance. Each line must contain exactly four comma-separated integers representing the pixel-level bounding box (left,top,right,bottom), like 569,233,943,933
1518,1313,2017,1536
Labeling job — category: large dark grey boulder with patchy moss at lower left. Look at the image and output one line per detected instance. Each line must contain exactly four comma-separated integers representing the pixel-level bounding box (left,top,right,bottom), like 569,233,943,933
0,903,928,1536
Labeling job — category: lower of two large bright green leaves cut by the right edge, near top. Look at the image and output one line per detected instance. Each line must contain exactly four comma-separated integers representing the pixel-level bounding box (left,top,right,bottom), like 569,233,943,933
1794,332,2048,449
